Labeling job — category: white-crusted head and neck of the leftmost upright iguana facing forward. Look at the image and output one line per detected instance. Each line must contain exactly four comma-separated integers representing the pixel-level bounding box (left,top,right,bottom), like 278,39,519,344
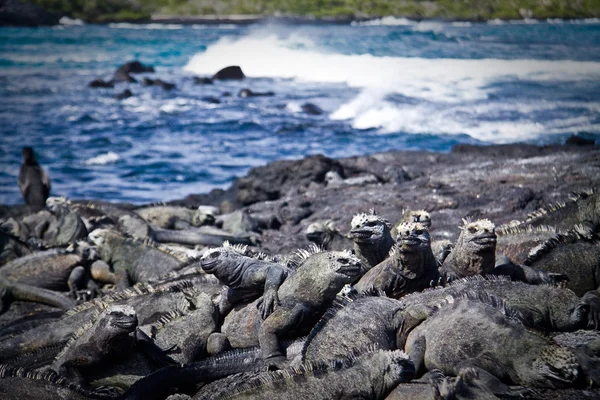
350,210,394,272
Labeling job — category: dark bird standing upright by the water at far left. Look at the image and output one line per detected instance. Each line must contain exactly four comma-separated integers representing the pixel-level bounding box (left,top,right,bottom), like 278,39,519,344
19,147,50,207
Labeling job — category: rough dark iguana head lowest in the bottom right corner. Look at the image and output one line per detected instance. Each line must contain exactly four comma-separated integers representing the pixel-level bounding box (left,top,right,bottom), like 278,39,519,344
532,343,579,387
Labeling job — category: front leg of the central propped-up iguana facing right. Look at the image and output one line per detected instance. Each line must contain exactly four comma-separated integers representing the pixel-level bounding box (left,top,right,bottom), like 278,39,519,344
258,304,305,363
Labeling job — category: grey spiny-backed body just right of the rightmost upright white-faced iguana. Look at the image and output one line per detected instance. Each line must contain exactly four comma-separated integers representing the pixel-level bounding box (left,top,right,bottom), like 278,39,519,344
496,225,558,264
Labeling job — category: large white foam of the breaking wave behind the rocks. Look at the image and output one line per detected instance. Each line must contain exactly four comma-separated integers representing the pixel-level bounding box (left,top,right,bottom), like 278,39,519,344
185,32,600,142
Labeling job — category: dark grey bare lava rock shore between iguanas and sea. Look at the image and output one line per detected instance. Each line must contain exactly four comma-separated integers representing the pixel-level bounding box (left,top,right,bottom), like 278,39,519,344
169,144,600,253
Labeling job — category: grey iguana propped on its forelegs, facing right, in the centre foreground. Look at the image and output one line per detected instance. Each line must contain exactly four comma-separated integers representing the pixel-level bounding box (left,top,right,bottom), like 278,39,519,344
221,248,364,363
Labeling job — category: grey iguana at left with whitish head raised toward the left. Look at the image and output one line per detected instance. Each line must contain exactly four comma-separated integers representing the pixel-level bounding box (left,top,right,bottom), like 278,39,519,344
89,229,181,289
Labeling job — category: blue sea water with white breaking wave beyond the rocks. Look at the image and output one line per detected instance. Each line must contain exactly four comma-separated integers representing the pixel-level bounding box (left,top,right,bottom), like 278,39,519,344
0,18,600,204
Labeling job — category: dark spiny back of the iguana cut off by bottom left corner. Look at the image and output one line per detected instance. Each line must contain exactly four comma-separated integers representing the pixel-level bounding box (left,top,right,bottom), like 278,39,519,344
0,365,116,400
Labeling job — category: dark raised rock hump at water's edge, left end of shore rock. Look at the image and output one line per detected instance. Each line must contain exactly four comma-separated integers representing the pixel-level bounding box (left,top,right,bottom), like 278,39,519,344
234,155,344,205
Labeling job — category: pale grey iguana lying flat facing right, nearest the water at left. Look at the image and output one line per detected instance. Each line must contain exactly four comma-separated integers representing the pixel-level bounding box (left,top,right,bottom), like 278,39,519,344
135,205,218,229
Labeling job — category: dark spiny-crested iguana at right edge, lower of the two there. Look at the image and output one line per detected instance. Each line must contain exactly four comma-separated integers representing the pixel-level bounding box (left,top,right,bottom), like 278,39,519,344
524,226,600,328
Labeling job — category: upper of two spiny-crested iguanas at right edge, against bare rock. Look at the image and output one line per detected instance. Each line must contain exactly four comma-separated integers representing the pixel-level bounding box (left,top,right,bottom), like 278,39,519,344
525,190,600,233
